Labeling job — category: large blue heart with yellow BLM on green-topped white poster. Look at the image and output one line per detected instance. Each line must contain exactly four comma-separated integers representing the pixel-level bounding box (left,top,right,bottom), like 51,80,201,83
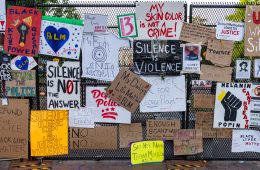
44,26,70,53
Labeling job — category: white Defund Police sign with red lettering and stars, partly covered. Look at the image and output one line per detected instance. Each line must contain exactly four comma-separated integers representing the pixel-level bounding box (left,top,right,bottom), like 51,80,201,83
86,87,131,124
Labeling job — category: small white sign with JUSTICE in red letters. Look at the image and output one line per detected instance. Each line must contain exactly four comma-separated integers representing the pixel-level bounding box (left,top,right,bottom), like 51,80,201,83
216,21,245,41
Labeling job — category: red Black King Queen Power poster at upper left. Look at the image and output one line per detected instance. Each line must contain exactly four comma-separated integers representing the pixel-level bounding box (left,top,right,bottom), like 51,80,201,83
1,4,42,56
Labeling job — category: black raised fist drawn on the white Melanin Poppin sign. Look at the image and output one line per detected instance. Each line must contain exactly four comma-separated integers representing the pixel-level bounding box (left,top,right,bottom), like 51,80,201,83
221,91,242,121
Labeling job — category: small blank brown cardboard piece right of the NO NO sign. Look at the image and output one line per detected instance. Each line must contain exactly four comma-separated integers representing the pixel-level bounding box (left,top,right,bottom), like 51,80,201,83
119,123,143,148
